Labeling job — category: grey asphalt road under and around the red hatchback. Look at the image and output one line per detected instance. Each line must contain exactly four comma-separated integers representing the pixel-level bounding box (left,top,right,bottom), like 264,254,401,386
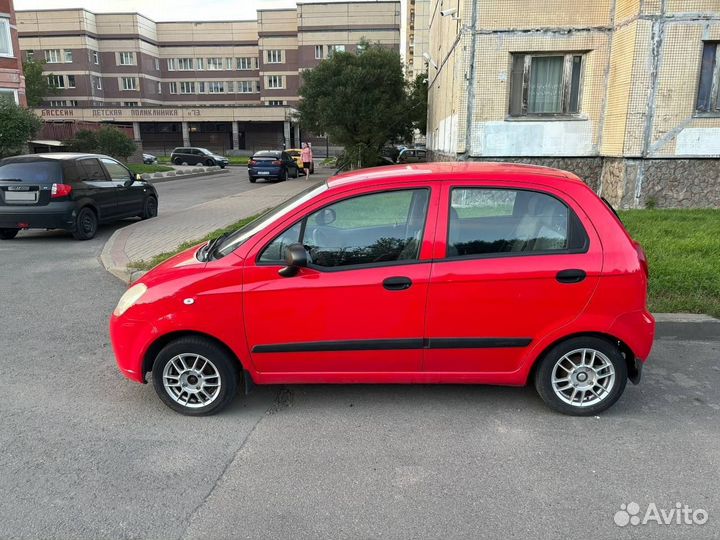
0,170,720,539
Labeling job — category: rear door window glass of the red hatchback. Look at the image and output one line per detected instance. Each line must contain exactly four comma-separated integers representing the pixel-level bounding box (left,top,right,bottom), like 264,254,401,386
447,188,588,257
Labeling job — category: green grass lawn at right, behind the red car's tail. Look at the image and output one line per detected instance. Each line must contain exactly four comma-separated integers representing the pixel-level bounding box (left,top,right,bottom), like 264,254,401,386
620,210,720,317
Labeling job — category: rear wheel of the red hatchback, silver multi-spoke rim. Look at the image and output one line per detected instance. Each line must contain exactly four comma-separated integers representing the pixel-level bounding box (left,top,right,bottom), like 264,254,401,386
535,336,627,416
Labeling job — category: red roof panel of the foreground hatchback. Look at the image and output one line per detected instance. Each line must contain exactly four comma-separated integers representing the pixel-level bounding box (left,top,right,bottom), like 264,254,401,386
327,161,582,188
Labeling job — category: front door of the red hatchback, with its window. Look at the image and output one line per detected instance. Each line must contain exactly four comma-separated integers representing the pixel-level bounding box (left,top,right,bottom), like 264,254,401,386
243,186,436,381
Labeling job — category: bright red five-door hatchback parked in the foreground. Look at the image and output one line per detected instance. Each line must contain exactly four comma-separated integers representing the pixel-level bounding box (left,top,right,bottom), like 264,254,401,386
110,163,655,415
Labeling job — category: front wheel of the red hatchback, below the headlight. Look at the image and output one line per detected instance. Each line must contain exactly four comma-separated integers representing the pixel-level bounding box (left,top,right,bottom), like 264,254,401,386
152,336,240,416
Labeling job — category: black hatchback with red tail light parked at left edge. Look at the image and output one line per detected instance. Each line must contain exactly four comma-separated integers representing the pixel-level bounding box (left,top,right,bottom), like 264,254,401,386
0,152,158,240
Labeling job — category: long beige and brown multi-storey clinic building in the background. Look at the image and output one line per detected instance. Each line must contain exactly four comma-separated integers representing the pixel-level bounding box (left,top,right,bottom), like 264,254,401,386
17,0,400,151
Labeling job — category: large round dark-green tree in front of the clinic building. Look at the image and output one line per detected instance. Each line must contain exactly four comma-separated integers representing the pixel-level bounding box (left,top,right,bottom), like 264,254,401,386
298,42,412,166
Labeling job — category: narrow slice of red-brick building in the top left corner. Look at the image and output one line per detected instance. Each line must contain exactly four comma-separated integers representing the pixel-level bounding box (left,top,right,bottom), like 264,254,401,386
0,0,27,105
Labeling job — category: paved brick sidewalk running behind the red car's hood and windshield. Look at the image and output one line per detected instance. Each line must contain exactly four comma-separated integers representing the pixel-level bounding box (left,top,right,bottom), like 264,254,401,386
100,178,321,282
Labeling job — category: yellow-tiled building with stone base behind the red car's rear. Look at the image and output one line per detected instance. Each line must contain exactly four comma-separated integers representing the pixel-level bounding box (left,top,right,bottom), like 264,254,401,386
427,0,720,207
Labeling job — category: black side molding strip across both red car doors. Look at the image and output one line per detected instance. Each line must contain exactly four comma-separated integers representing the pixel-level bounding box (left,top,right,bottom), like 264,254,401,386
252,338,532,353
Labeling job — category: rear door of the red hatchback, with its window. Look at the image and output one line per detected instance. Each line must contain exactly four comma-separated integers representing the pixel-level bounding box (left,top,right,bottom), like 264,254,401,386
423,182,602,373
